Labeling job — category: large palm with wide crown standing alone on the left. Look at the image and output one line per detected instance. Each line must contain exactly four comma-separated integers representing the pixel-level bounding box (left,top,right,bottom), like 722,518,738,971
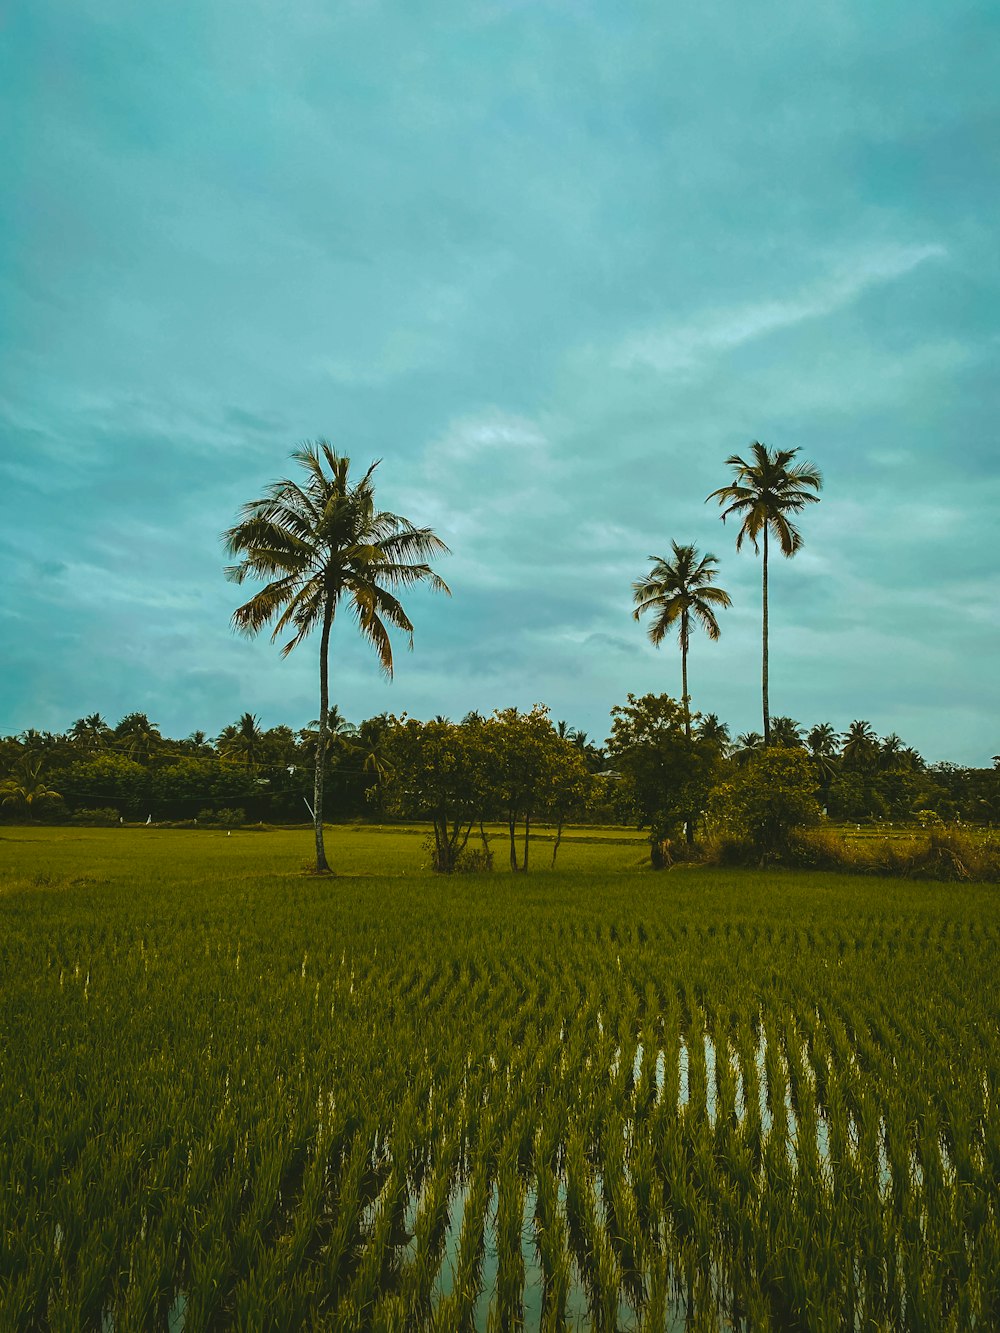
223,440,448,873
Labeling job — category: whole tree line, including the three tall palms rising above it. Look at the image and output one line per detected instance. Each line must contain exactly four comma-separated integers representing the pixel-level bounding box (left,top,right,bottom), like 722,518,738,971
0,441,1000,873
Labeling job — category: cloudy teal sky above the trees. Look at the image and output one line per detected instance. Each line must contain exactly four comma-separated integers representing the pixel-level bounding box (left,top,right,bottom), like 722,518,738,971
0,0,1000,765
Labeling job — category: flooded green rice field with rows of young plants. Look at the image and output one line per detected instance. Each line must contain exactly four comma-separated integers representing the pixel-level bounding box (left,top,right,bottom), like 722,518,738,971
0,829,1000,1333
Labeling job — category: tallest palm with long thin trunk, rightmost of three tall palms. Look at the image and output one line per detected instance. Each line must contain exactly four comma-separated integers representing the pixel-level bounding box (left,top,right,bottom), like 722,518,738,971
705,440,823,745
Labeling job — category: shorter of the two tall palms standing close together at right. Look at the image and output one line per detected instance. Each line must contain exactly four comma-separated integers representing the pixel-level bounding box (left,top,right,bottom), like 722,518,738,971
632,541,732,740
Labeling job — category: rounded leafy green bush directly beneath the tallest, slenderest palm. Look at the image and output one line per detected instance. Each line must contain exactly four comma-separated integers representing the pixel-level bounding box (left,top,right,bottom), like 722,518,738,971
712,746,820,858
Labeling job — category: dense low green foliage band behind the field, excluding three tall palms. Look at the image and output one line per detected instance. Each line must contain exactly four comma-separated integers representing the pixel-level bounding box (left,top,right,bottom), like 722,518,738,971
0,694,1000,865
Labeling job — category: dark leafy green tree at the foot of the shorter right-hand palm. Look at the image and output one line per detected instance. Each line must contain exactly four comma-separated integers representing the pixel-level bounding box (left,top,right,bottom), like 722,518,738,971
608,694,720,864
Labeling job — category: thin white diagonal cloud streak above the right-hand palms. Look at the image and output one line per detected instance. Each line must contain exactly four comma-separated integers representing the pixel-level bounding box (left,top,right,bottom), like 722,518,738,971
615,245,948,373
